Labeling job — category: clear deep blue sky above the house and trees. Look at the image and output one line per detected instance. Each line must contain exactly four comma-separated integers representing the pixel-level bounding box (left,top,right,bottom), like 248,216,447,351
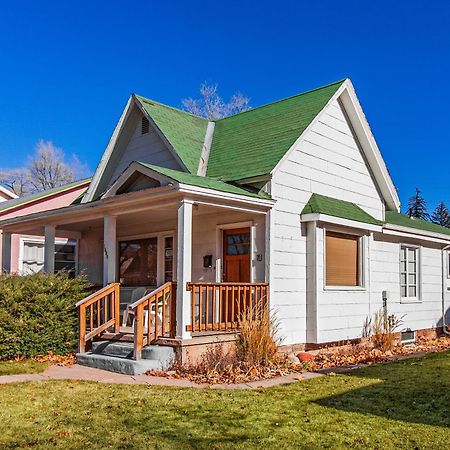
0,0,450,211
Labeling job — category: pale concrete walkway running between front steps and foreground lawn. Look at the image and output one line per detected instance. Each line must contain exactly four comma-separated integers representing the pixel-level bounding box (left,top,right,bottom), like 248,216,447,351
0,364,321,389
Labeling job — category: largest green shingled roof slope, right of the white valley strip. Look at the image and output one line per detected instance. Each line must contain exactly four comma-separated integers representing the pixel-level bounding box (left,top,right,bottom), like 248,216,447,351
207,80,344,180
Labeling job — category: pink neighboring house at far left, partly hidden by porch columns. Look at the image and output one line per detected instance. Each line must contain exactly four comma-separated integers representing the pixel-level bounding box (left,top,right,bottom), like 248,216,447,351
0,179,91,274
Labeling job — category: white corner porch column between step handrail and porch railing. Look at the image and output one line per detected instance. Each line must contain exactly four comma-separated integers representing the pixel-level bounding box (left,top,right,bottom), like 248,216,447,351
177,200,192,339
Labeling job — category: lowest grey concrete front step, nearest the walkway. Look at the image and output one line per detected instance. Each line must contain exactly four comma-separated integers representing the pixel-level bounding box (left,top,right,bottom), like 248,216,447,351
77,352,162,375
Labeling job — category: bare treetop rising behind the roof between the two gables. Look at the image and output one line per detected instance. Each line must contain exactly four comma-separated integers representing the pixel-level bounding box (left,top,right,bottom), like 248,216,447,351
181,83,250,120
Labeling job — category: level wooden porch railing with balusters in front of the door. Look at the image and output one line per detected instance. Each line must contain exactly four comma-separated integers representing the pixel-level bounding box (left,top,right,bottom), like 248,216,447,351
186,283,269,331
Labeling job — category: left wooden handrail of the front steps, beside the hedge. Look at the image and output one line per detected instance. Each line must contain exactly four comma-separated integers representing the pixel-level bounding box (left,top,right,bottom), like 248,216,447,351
75,283,120,353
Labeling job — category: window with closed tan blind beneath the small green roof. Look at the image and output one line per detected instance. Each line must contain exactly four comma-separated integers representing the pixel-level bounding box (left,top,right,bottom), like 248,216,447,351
325,231,360,287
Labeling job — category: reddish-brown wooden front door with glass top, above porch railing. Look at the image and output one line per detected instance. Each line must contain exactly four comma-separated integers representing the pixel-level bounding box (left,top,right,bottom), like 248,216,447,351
223,228,250,283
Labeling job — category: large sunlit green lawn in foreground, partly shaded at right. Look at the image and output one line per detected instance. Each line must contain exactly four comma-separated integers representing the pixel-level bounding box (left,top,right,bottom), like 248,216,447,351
0,352,450,450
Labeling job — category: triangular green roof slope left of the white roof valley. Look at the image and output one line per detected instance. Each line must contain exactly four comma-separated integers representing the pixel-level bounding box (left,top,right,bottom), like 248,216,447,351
136,95,208,174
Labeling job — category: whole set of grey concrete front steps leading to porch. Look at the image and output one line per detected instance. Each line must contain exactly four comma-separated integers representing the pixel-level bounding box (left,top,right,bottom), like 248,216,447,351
77,341,175,375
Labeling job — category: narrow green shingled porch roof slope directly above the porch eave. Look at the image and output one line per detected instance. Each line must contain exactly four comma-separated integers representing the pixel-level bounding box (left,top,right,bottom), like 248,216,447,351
139,162,270,199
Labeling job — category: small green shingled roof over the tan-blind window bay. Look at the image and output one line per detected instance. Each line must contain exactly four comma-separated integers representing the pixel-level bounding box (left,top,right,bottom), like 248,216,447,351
302,194,381,225
